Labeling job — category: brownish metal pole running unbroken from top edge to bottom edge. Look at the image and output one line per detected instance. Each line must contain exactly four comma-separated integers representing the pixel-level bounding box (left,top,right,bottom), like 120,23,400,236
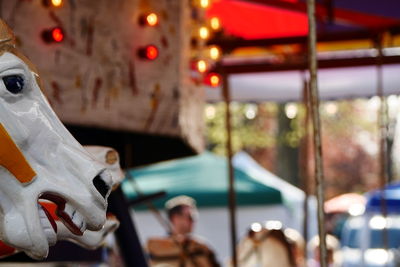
307,0,327,267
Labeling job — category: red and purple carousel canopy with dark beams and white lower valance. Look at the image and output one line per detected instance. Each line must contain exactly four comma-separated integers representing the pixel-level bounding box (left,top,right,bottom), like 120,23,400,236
206,0,400,102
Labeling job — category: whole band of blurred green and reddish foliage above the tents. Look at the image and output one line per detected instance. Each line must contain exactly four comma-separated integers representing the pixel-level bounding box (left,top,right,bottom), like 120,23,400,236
205,98,396,198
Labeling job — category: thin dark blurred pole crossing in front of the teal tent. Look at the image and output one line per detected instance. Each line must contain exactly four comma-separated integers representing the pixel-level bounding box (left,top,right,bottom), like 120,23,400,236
222,73,238,267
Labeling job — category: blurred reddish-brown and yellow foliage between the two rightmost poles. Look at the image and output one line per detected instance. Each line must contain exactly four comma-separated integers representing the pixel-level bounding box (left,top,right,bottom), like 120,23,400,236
321,99,379,198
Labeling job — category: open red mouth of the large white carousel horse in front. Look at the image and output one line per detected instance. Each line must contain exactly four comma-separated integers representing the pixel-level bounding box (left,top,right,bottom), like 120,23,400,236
40,194,86,236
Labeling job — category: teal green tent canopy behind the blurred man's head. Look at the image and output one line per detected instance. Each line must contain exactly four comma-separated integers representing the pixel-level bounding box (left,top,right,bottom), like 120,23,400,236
122,152,282,208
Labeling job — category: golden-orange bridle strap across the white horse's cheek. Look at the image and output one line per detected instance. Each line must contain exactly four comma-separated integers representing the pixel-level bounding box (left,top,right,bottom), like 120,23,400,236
0,123,36,183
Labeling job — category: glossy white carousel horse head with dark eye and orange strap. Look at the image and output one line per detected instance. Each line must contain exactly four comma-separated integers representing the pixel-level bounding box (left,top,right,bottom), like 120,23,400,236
0,20,113,259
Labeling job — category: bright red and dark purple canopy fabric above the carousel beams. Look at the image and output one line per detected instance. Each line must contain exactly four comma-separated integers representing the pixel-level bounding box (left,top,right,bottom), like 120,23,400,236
207,0,400,39
